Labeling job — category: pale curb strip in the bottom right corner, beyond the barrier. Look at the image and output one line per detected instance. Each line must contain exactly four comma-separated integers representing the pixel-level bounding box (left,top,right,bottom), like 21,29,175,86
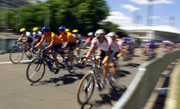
165,61,180,109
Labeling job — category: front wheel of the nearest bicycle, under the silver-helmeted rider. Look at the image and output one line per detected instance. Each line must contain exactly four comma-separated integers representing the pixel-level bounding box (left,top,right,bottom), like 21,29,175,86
77,72,94,104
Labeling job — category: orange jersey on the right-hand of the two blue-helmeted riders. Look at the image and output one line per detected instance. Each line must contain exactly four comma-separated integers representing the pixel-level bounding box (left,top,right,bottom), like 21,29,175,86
59,32,76,43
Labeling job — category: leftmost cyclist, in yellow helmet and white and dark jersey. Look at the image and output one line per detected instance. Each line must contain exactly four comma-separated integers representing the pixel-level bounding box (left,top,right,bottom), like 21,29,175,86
15,28,34,52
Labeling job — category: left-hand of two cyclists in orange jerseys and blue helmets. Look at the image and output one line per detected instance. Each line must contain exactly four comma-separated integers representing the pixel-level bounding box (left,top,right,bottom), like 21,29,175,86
34,26,62,74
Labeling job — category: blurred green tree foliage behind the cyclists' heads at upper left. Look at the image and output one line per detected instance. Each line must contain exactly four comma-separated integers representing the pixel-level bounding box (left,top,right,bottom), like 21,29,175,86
0,0,128,34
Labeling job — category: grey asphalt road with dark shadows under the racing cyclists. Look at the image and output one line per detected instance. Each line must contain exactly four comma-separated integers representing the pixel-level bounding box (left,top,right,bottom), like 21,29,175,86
0,49,149,109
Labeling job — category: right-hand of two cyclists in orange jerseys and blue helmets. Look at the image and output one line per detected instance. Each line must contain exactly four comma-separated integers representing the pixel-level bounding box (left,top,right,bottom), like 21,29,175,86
58,26,76,68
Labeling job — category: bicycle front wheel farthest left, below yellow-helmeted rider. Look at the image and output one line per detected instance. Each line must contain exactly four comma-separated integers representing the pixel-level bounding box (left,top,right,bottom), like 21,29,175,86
9,47,24,64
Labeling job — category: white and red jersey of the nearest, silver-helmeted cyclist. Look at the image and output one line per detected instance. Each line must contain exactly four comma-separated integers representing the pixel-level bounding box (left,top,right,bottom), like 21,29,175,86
91,37,110,51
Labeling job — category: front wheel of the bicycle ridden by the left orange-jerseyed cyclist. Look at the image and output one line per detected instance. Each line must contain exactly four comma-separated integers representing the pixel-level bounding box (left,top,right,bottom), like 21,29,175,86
26,59,45,83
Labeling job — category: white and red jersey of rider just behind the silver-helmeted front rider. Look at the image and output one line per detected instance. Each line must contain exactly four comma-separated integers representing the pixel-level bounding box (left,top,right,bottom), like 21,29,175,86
107,37,123,52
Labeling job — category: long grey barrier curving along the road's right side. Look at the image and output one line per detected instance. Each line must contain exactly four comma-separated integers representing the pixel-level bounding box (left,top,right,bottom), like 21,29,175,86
112,50,180,109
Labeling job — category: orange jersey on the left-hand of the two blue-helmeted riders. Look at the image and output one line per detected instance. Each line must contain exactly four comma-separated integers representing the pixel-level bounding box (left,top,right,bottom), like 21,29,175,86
41,32,63,45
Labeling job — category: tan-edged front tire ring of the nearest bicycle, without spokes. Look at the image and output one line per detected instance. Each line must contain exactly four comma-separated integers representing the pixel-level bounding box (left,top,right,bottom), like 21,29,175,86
77,72,95,104
